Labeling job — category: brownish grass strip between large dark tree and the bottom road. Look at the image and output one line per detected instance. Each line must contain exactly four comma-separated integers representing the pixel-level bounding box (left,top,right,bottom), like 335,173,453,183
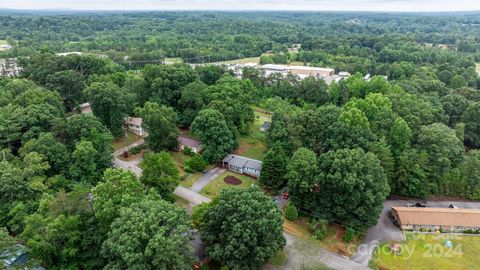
283,218,361,257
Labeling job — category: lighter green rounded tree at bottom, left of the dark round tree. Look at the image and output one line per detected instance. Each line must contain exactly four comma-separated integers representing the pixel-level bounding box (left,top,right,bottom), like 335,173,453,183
102,195,193,270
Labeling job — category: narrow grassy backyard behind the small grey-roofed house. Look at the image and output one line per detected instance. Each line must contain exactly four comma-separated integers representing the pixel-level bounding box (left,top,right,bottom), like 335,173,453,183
235,107,271,160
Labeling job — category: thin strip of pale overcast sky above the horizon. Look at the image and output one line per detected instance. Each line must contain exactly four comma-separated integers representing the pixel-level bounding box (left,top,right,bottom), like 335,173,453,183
0,0,480,12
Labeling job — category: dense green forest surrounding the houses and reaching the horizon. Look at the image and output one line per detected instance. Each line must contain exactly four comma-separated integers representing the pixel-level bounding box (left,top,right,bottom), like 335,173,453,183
0,11,480,269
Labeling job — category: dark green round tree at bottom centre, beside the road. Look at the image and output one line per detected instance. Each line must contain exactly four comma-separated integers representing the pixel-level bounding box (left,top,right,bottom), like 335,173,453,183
200,186,285,269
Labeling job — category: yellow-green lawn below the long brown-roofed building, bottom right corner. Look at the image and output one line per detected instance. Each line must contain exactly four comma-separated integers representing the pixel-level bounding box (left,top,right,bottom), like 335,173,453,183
371,233,480,270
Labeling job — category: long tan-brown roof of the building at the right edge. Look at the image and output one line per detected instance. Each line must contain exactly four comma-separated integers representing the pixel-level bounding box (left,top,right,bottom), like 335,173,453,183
392,207,480,227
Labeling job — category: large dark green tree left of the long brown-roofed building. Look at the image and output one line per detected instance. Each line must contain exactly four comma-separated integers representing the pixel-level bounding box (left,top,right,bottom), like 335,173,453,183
316,149,390,229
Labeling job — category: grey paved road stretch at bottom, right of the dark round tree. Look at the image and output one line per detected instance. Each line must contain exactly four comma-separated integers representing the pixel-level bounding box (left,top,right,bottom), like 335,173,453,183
263,233,369,270
